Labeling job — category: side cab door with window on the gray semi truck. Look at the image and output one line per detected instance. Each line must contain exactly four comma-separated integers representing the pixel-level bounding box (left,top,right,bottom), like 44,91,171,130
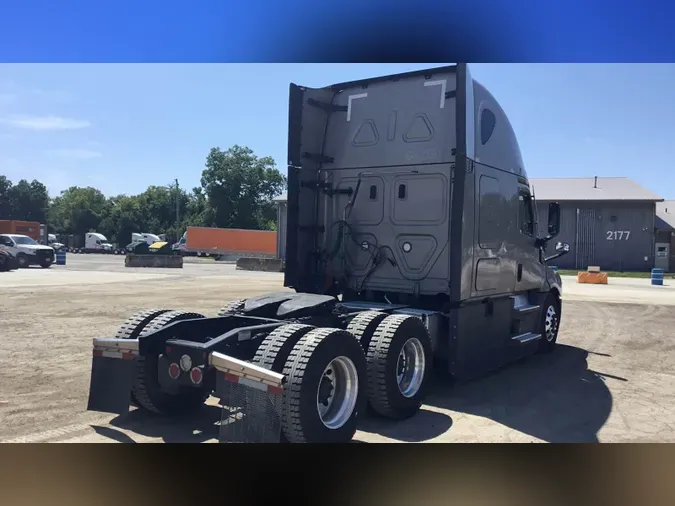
514,184,545,293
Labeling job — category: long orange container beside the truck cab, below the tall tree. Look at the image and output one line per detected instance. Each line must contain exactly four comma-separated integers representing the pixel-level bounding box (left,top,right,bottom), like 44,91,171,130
185,227,277,256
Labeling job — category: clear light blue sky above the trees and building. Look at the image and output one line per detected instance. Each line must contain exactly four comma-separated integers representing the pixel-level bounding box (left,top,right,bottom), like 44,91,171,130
0,63,675,199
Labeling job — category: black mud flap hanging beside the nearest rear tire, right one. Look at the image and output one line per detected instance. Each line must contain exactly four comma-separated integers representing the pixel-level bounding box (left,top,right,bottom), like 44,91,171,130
215,372,283,443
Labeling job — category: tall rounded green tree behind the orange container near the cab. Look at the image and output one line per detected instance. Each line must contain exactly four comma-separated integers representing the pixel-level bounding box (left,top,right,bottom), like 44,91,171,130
201,145,286,229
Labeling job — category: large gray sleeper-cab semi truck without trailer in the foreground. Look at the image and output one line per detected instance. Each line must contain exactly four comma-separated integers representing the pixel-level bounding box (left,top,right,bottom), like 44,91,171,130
88,63,569,443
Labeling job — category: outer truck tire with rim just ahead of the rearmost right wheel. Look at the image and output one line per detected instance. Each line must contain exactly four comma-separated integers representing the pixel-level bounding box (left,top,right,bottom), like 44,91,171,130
366,315,433,420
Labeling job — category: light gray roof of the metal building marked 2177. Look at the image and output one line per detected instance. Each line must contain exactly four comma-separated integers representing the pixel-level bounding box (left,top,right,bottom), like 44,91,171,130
530,177,663,202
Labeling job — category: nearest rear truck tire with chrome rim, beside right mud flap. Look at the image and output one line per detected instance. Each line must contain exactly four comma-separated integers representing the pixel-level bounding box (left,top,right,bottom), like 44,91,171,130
281,328,367,443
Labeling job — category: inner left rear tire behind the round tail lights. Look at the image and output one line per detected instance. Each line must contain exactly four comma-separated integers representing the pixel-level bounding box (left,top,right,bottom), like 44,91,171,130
132,311,211,415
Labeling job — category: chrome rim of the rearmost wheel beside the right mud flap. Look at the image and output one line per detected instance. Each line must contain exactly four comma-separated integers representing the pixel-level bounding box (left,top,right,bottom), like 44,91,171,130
316,357,359,430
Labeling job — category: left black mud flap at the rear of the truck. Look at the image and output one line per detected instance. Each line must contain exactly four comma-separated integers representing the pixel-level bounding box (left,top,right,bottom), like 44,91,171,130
87,356,137,415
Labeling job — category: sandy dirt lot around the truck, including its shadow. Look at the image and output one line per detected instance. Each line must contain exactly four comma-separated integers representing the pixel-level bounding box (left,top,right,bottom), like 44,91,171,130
0,255,675,442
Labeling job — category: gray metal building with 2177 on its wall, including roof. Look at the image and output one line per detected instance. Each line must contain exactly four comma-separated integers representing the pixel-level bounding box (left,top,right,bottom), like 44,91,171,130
530,177,663,271
